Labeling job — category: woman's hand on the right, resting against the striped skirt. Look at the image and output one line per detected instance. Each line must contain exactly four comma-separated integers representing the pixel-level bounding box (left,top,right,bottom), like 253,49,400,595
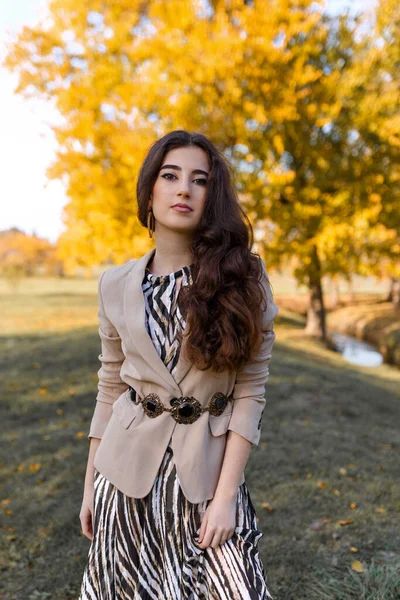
198,496,237,549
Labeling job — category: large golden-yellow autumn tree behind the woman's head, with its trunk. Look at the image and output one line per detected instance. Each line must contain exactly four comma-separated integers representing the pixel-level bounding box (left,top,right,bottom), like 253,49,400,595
5,0,396,337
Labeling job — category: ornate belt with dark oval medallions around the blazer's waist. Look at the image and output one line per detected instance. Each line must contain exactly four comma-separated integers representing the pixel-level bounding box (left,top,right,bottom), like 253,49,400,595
129,387,233,424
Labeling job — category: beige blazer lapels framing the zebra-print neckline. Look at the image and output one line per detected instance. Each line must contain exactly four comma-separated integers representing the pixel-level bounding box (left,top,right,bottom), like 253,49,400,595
124,248,192,396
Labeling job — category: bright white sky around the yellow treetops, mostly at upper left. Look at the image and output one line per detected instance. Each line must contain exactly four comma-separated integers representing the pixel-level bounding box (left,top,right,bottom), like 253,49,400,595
0,0,377,242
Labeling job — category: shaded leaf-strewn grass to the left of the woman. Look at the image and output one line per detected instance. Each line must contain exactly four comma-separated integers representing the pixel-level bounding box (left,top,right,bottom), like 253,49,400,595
0,329,100,600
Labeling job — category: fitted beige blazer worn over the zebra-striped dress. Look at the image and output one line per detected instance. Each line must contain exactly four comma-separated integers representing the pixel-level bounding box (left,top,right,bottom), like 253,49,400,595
88,248,278,503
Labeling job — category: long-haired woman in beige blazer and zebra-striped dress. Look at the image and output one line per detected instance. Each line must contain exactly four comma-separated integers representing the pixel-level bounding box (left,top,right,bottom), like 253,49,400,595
80,130,278,600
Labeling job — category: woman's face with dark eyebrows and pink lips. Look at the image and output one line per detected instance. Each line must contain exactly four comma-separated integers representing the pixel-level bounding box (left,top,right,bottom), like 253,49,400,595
152,146,210,234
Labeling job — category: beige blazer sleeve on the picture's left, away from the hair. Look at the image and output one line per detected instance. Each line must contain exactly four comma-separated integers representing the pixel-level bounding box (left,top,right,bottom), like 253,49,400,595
88,271,128,439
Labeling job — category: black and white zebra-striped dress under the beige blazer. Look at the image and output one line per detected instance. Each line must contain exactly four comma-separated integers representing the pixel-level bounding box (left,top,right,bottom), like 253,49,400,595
79,265,272,600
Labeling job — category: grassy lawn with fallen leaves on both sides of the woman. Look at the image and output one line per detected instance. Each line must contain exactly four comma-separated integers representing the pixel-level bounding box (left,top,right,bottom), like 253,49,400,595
0,280,400,600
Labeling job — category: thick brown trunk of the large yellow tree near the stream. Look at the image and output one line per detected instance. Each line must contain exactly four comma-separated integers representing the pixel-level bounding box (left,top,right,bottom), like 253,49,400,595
305,246,326,341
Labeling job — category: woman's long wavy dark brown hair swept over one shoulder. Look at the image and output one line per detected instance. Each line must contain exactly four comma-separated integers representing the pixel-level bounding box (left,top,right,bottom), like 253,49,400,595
136,130,267,372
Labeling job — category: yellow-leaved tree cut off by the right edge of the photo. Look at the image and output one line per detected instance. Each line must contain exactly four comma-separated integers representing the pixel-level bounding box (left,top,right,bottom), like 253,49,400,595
320,0,400,305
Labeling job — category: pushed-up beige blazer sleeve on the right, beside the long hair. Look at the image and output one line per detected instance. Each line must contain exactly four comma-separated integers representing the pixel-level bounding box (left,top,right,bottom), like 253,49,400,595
228,259,279,446
